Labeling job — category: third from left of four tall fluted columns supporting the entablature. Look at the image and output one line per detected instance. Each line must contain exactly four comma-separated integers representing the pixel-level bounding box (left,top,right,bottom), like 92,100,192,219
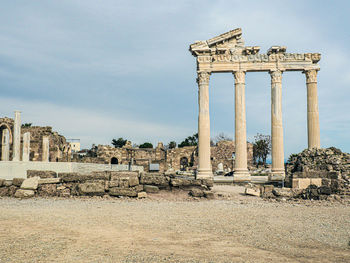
269,70,285,181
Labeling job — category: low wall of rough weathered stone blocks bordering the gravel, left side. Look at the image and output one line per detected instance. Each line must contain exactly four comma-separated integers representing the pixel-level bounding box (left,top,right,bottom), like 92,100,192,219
0,170,213,198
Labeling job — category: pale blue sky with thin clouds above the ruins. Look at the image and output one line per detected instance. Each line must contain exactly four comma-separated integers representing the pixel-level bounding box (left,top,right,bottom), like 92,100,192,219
0,0,350,156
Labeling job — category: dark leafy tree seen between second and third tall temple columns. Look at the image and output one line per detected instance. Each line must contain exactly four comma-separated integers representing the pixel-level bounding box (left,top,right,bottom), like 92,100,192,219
253,133,271,165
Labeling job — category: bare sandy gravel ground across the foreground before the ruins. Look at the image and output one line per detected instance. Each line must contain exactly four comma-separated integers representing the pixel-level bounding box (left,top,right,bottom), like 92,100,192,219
0,186,350,263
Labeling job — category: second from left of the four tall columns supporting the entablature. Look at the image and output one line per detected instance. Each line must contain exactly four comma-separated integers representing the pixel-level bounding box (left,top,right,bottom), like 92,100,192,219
233,71,251,181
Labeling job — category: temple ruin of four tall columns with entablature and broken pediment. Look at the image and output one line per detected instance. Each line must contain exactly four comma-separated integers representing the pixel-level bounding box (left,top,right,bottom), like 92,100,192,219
190,28,321,181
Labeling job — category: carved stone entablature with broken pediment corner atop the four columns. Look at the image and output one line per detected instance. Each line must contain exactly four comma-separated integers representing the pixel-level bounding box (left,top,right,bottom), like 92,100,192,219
190,28,321,72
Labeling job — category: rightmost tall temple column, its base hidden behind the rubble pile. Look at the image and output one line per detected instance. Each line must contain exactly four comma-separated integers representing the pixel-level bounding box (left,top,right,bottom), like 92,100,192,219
304,69,321,149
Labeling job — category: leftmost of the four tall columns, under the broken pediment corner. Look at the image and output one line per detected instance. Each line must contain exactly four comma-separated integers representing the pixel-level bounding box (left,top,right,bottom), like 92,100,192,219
197,72,213,178
